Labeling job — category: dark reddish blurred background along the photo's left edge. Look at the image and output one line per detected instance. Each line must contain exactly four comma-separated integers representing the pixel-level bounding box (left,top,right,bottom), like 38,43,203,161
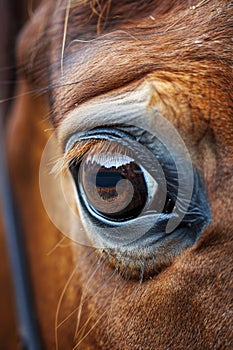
0,0,39,350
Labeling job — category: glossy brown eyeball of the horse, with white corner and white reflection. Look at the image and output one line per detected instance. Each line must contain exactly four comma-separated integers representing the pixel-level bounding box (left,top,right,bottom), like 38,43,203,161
77,147,158,221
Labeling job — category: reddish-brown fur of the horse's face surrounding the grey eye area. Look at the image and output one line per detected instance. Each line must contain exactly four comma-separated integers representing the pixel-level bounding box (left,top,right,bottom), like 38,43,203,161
0,0,233,350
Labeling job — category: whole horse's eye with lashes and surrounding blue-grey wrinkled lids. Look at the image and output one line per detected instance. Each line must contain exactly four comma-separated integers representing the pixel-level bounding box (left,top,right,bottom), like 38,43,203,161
62,126,210,278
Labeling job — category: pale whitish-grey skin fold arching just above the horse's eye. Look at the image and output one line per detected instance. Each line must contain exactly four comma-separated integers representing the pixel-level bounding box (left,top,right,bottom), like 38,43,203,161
57,82,156,150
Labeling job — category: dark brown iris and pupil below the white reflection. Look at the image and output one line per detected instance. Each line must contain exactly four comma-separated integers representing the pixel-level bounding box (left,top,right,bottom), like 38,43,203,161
80,161,148,221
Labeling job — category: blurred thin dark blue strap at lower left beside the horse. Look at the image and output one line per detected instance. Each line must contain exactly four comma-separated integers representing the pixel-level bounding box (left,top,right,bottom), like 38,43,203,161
0,115,42,350
